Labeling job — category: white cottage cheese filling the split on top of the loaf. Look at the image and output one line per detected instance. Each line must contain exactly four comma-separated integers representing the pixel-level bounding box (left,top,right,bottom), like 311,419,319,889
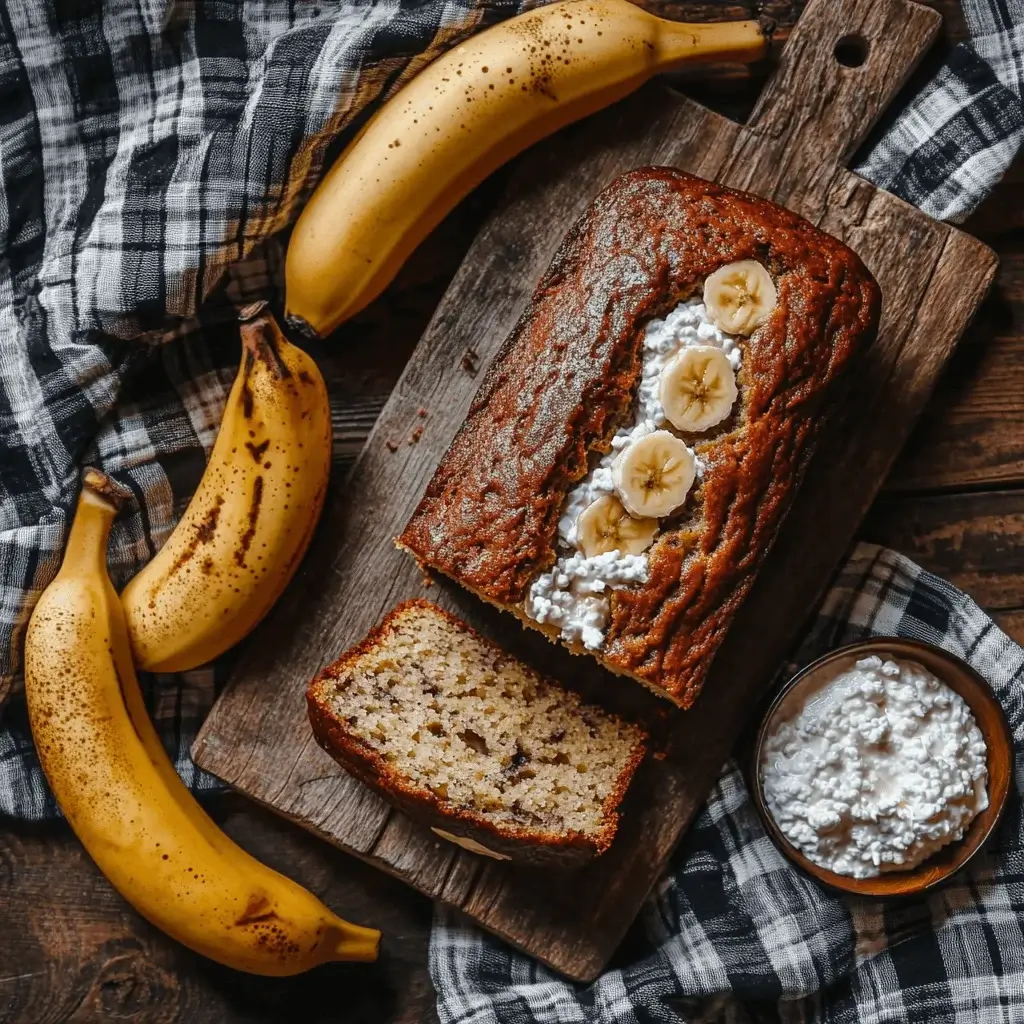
525,298,740,650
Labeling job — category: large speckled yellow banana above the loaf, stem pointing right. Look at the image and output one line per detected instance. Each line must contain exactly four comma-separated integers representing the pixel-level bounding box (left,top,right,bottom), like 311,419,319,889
286,0,767,335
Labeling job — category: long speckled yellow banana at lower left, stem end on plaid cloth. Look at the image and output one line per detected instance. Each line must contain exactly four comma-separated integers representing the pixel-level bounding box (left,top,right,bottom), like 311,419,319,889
25,470,380,975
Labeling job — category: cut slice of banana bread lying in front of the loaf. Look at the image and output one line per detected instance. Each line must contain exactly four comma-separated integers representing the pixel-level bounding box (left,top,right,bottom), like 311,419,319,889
306,601,646,866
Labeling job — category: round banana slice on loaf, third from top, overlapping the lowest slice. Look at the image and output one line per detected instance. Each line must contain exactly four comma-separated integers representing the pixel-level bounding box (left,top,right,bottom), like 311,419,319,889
611,430,696,519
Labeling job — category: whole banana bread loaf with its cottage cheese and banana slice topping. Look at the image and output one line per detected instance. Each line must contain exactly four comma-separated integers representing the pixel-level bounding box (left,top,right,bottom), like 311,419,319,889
397,167,881,708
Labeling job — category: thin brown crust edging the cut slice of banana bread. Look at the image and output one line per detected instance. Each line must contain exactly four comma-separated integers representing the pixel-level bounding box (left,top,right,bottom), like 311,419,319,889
306,599,646,867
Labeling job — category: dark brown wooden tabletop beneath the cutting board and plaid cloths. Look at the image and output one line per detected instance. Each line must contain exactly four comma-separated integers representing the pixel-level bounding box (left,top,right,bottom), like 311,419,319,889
0,0,1024,1024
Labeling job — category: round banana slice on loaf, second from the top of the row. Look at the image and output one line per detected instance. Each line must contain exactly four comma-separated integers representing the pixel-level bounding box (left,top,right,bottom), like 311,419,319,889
658,345,739,432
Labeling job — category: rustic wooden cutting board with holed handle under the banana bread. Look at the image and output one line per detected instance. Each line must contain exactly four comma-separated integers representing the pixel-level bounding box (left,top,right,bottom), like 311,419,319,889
194,0,995,980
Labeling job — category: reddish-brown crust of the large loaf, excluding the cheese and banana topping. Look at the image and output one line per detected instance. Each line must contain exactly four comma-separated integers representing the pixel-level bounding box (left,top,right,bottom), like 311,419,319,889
398,168,881,707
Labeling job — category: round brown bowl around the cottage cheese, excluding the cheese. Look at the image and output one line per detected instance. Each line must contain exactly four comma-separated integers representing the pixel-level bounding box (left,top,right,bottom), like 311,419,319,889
751,637,1014,896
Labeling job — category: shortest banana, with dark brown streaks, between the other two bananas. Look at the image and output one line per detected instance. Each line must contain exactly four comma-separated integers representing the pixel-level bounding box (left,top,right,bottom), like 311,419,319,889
121,307,331,672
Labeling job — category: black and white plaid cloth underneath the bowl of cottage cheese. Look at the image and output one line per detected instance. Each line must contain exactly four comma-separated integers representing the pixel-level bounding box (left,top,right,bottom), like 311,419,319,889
430,545,1024,1024
